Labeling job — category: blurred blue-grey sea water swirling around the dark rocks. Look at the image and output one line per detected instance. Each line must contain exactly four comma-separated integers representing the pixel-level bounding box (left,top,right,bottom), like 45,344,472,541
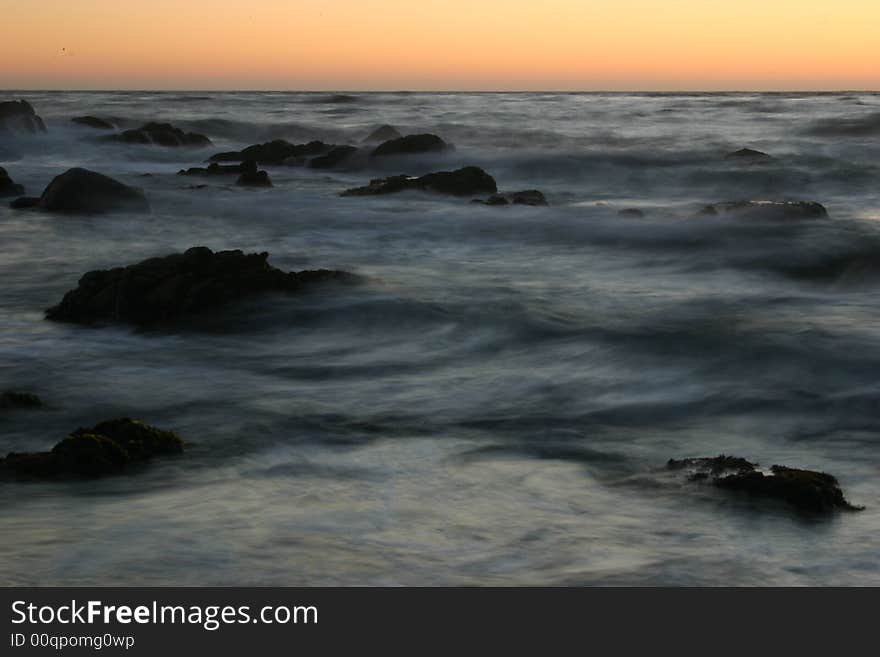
0,92,880,585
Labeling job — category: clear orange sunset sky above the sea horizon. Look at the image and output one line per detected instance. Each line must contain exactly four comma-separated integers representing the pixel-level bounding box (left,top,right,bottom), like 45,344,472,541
0,0,880,90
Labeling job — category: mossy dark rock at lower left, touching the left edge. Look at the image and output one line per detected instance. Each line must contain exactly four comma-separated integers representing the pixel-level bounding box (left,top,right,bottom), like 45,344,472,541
0,418,184,479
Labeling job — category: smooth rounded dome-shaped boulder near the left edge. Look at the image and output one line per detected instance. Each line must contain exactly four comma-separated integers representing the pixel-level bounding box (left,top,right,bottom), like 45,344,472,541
12,168,150,212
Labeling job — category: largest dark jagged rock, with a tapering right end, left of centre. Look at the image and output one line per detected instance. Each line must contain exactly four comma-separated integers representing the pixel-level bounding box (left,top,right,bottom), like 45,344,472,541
46,246,358,326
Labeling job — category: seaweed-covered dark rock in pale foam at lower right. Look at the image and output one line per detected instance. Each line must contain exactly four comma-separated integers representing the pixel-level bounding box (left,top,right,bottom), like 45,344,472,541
667,454,863,513
